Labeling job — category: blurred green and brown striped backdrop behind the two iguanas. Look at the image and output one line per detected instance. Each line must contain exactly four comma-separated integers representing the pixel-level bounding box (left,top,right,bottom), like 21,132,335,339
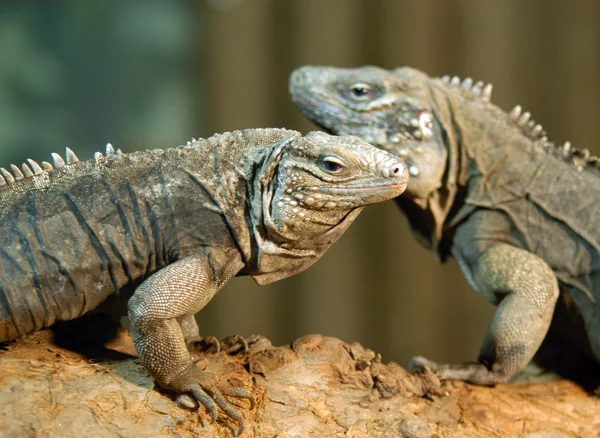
0,0,600,365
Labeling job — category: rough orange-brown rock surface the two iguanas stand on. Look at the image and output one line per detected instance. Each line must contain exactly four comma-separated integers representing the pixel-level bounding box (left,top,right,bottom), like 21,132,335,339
0,331,600,438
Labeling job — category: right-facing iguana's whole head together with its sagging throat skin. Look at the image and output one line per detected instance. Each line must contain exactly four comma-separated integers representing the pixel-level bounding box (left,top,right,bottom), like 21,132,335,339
248,131,408,284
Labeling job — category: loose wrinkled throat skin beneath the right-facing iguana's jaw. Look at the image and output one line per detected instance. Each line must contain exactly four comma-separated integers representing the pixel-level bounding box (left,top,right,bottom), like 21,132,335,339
248,145,363,285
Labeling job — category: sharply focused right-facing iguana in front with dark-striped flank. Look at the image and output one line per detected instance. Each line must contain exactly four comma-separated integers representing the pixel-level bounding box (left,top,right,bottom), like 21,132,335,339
0,129,408,433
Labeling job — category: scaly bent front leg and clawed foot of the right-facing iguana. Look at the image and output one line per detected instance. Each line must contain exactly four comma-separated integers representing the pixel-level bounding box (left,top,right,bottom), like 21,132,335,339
128,250,254,433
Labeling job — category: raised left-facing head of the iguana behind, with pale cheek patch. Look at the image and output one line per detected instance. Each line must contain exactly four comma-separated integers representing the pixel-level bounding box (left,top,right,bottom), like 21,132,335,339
290,66,448,198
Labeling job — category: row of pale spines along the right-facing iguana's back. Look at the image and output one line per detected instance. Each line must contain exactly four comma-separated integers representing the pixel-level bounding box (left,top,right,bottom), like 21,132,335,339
0,143,123,187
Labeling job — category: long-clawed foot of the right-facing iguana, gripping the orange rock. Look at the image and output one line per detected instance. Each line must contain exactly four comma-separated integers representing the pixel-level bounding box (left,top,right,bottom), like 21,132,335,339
167,363,256,436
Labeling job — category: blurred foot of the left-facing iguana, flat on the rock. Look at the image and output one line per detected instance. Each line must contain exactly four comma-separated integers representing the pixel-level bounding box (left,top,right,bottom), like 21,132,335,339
407,356,508,386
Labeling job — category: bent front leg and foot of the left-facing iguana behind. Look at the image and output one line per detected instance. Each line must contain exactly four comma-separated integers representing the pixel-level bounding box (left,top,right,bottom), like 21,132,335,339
409,243,559,385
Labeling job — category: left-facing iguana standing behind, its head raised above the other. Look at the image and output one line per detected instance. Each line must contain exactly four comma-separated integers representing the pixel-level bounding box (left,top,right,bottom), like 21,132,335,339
290,66,600,385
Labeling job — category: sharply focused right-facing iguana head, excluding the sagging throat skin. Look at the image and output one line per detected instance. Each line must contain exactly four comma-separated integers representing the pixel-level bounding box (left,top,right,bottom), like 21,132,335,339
271,132,408,235
